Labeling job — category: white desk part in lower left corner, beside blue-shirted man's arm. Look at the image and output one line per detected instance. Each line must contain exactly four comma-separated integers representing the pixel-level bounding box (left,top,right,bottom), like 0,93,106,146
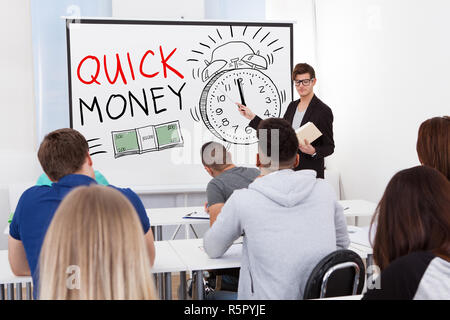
0,250,32,300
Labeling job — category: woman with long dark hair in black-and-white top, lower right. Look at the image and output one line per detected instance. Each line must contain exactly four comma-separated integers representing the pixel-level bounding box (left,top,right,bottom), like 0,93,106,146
363,166,450,300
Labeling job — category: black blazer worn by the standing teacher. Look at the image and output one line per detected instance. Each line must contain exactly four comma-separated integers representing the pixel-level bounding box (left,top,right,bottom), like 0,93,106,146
249,95,334,178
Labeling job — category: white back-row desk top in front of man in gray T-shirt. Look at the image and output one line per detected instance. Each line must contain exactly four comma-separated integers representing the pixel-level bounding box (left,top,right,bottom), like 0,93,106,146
146,207,209,227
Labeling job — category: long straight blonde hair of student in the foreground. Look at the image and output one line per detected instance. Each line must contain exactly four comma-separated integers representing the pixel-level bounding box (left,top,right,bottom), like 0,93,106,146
39,185,156,300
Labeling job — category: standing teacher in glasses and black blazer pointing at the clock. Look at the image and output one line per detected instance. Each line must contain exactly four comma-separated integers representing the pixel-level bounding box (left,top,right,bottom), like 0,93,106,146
238,63,334,178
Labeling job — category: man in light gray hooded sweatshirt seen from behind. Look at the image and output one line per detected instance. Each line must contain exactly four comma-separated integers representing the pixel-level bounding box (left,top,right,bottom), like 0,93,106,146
204,118,350,299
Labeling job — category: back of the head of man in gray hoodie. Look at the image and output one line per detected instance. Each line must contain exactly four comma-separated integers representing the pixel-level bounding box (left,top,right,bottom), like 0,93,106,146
256,118,298,167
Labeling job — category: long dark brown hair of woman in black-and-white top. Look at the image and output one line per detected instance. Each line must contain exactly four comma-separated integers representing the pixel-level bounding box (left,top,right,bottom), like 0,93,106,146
371,166,450,269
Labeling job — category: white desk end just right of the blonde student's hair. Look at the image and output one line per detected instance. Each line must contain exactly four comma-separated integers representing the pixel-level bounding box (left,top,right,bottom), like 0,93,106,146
152,241,186,273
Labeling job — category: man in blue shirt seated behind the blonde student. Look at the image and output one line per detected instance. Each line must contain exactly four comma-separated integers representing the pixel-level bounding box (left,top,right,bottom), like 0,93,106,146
8,128,155,298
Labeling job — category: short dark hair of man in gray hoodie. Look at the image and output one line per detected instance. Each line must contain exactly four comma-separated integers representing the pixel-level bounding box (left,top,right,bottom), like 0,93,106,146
256,118,298,166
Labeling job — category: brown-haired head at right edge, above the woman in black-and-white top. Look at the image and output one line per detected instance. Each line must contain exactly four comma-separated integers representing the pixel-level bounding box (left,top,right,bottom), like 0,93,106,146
416,116,450,180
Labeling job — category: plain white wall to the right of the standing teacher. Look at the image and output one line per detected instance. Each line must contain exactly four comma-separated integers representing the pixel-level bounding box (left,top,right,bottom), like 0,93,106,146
316,0,450,201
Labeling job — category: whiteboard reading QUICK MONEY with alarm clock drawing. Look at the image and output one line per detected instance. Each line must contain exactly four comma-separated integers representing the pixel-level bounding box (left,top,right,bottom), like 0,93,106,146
66,19,293,186
